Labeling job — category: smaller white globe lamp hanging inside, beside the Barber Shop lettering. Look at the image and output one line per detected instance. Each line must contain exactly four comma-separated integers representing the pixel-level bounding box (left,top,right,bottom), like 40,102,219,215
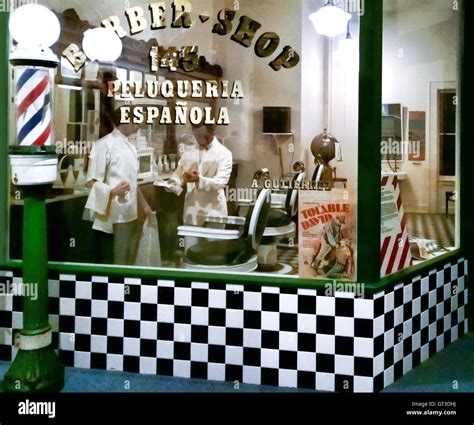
82,28,123,63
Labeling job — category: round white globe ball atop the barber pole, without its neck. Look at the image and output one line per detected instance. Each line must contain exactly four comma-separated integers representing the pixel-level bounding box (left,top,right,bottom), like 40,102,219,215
9,4,61,48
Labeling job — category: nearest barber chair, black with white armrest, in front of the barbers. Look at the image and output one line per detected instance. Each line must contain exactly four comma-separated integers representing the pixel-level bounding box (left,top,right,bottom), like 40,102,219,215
178,189,271,273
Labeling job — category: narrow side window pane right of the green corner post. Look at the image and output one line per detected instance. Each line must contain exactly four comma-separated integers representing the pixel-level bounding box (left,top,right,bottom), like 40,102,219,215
382,0,461,276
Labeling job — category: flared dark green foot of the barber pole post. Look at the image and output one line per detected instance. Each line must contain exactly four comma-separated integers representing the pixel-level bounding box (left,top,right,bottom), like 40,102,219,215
3,345,64,393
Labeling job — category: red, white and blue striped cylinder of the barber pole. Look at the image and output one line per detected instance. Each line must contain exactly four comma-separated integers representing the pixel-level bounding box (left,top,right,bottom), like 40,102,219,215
14,66,53,146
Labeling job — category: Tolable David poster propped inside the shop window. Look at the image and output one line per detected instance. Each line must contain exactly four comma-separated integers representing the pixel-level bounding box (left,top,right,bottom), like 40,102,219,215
298,189,356,280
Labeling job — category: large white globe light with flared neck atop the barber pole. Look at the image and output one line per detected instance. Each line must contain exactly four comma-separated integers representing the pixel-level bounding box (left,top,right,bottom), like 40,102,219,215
9,4,61,62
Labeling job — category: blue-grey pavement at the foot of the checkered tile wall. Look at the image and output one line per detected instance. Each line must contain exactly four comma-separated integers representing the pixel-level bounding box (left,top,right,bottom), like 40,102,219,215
0,334,474,393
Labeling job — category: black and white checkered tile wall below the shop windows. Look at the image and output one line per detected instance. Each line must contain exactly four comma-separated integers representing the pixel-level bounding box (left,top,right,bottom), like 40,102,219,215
0,260,467,392
